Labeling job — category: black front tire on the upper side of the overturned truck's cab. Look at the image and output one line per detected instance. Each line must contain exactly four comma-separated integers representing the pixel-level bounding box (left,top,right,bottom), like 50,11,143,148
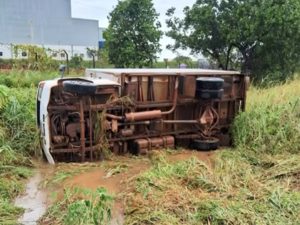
63,80,97,95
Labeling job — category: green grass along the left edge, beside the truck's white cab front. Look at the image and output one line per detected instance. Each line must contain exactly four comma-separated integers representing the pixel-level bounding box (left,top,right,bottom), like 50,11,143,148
0,79,37,224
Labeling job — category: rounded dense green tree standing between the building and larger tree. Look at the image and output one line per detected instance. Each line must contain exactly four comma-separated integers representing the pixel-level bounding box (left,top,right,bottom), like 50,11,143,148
104,0,162,68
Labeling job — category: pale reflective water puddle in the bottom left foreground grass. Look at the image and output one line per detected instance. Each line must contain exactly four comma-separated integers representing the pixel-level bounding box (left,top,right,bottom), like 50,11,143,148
15,164,53,225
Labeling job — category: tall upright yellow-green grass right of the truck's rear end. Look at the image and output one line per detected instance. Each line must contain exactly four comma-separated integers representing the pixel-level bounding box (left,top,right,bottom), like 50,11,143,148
233,80,300,154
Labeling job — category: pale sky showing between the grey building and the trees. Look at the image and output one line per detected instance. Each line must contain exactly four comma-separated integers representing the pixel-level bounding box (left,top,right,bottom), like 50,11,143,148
72,0,196,60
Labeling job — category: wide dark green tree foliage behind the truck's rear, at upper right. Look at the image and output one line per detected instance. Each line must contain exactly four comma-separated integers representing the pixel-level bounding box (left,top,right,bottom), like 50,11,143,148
167,0,300,83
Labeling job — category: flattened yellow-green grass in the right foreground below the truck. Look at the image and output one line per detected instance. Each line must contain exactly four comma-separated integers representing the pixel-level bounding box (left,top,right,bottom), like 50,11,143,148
124,150,300,224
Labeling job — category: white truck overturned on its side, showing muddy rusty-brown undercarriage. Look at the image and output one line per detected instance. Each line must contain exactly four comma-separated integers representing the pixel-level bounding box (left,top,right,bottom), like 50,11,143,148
37,69,249,164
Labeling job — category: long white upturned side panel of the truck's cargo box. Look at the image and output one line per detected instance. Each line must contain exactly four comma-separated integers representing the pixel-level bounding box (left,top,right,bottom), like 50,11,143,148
86,69,241,75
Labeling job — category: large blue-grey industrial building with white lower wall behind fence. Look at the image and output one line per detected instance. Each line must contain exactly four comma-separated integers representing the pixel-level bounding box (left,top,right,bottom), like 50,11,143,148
0,0,103,60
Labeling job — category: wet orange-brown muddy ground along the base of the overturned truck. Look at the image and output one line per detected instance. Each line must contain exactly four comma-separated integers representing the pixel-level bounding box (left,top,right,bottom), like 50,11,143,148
15,150,214,225
